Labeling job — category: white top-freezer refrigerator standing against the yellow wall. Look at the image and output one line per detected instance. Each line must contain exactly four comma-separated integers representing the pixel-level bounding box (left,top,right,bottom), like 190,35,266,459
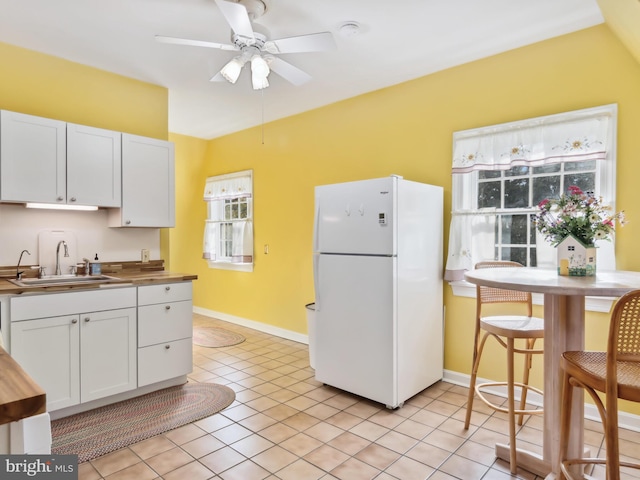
312,176,443,408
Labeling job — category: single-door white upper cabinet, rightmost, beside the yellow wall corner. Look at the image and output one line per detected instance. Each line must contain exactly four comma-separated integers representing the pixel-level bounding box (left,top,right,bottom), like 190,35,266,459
110,133,175,227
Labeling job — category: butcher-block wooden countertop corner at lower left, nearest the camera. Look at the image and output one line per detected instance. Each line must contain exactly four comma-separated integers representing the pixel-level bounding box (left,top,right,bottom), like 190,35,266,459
0,347,47,425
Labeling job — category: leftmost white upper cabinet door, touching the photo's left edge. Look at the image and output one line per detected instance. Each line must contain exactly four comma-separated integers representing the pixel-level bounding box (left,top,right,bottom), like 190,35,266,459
0,110,66,203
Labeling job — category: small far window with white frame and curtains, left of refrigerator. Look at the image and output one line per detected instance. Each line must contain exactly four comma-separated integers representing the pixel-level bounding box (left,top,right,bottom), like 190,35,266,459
203,170,255,272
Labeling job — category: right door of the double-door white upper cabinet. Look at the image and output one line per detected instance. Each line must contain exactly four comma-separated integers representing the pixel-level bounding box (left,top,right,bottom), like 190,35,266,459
67,123,122,207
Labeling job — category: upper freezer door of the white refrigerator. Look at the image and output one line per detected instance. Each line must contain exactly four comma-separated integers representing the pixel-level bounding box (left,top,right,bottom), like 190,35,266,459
314,177,398,255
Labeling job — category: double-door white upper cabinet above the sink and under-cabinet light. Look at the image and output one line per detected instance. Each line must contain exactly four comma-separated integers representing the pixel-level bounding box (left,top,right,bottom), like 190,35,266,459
0,110,122,207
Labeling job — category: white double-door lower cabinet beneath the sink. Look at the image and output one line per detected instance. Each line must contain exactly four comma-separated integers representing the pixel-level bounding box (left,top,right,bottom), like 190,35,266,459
11,287,137,411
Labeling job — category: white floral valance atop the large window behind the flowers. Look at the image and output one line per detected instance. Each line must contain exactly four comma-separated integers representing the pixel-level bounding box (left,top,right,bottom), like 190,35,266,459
452,106,613,173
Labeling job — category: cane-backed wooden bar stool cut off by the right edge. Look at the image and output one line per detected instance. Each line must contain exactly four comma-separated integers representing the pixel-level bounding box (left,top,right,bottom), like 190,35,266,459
560,290,640,480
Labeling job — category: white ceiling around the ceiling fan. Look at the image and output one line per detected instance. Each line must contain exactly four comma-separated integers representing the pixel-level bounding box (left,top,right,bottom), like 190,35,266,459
0,0,604,139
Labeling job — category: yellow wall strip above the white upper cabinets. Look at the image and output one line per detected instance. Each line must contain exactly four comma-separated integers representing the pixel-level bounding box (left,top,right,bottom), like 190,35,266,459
0,43,169,140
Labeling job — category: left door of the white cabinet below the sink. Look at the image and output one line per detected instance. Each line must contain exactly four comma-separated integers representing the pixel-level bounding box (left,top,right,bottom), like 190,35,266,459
11,315,80,411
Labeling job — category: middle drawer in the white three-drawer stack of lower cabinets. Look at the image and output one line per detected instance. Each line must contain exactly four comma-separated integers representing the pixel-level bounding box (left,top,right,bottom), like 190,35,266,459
138,300,193,347
